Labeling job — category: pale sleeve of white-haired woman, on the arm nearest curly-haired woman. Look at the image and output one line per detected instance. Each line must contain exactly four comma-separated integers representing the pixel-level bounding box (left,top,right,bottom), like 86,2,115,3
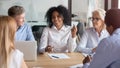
77,31,92,54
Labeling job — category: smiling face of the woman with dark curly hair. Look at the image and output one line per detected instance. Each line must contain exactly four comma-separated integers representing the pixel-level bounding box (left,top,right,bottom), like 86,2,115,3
52,11,63,28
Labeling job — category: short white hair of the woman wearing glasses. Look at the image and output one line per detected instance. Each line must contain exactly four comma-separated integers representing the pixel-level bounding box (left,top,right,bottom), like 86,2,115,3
92,8,106,29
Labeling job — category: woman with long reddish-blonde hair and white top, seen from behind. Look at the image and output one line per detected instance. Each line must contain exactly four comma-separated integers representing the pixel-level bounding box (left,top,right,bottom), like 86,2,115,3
0,16,27,68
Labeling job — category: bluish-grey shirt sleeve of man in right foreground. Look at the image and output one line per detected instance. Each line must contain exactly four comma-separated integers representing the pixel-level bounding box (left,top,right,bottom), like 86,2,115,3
88,39,113,68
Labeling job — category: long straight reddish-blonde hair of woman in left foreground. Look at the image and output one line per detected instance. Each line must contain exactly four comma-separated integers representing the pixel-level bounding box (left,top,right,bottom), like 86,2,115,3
0,16,17,68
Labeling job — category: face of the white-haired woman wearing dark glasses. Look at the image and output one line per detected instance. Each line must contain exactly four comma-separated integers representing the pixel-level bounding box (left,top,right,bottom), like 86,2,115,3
92,11,103,29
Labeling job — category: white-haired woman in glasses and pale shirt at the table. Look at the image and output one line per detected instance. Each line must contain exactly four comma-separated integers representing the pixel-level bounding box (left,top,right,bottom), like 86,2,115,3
77,9,109,54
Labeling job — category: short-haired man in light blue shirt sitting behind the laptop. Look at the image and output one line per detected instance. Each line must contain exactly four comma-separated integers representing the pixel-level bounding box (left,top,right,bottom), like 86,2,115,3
8,6,35,41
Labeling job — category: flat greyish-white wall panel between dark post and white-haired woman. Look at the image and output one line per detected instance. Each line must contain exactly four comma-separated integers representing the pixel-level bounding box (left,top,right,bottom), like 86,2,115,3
72,0,88,20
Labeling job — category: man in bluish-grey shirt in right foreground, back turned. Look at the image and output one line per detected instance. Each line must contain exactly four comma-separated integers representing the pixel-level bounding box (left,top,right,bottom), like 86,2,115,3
83,9,120,68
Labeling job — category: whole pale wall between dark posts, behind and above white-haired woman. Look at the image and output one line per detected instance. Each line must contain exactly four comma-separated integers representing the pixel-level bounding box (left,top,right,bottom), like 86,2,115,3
72,0,104,26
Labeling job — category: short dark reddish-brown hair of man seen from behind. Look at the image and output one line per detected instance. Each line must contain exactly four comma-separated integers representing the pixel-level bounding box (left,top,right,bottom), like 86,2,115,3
105,8,120,29
